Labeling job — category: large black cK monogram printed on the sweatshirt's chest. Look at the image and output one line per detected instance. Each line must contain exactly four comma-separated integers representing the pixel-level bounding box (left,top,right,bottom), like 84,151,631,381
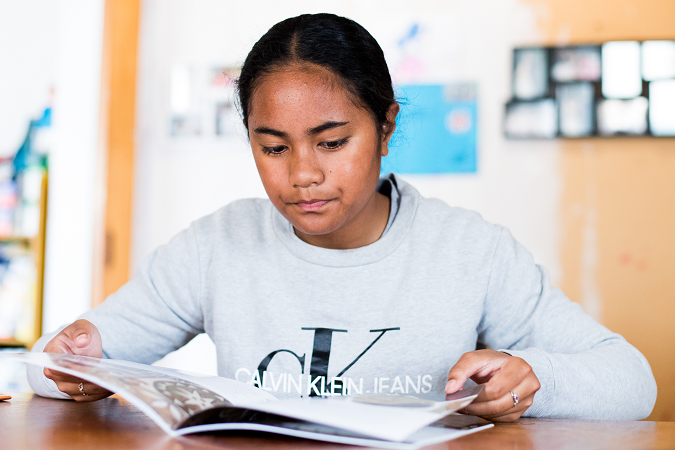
253,327,401,397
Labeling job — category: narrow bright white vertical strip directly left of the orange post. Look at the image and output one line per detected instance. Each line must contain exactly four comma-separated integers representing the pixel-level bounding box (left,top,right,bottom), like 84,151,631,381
43,0,104,332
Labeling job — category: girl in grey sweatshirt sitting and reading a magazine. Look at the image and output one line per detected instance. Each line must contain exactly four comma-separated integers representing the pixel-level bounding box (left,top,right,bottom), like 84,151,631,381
29,14,656,421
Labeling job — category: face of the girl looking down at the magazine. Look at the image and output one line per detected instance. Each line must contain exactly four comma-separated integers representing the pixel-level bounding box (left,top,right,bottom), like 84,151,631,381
248,64,398,248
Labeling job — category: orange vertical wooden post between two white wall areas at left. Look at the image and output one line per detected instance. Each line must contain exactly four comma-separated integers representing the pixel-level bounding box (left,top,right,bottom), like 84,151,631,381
92,0,141,307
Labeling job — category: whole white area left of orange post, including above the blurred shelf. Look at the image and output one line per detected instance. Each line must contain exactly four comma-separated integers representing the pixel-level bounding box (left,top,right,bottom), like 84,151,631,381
0,0,104,331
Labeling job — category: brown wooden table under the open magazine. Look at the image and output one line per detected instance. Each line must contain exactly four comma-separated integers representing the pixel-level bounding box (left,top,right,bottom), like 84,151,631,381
0,394,675,450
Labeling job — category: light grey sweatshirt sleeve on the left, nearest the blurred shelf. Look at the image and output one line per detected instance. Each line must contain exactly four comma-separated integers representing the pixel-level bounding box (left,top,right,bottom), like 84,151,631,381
27,226,204,399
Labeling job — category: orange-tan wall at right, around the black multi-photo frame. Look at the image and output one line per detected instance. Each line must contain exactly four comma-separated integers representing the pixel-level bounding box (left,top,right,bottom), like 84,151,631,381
528,0,675,421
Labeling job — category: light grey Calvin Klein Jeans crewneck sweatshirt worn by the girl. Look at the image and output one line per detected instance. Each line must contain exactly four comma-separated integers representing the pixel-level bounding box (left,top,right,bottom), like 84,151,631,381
29,175,656,420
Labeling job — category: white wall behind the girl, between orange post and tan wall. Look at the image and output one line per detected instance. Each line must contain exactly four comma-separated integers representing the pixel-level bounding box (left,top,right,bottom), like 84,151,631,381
132,0,560,371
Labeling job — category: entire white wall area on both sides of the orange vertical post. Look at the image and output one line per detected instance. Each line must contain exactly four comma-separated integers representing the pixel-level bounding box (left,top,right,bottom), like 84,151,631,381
0,0,560,372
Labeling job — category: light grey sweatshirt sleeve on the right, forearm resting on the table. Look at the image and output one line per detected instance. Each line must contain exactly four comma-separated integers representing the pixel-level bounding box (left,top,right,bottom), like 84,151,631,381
478,229,656,420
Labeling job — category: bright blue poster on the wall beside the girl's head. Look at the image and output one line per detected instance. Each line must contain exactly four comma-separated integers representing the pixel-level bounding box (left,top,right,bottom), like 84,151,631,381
382,84,478,174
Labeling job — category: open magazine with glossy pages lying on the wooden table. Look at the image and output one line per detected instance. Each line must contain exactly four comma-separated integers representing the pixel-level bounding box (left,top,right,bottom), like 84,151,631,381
0,353,492,449
